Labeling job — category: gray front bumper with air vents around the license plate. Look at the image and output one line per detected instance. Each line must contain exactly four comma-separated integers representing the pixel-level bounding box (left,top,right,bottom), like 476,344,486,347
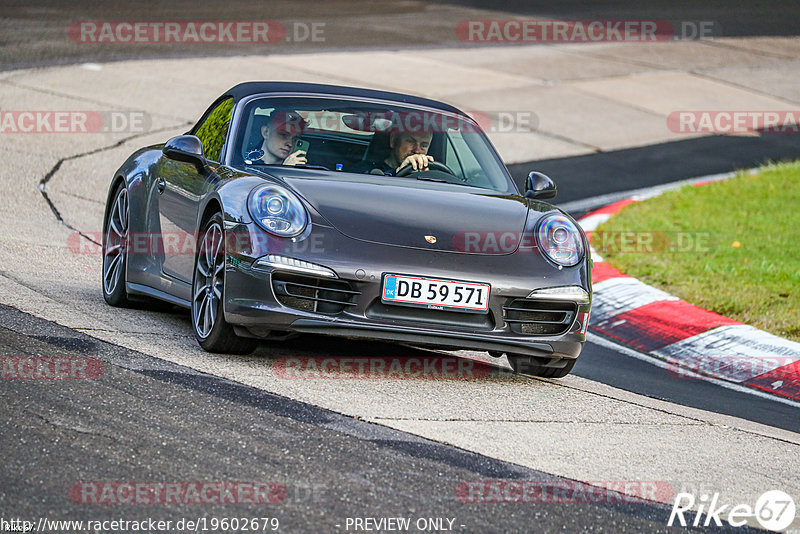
224,222,591,359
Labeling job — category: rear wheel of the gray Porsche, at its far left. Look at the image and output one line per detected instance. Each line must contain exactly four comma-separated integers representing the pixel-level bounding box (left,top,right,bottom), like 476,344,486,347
101,183,132,308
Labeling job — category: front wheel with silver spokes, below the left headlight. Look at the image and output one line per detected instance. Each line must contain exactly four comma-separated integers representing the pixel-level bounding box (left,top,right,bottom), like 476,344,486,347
192,213,258,354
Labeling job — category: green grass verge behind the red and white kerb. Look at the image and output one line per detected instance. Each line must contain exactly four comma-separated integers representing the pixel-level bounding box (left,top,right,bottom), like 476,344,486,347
592,162,800,341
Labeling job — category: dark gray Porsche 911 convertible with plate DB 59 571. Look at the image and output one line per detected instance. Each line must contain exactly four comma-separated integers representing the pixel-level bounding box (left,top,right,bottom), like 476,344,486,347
103,82,592,377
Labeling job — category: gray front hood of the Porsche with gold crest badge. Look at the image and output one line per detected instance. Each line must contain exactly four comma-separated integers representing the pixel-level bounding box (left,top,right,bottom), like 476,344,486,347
272,173,529,255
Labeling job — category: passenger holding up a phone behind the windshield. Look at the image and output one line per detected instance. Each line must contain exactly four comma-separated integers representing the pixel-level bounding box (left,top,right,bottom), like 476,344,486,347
245,109,307,166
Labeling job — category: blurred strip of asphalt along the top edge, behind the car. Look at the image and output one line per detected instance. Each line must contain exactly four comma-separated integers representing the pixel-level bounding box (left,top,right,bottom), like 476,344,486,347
0,0,800,70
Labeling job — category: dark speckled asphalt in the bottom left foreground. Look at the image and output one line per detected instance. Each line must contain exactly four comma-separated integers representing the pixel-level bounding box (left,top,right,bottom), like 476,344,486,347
0,306,746,532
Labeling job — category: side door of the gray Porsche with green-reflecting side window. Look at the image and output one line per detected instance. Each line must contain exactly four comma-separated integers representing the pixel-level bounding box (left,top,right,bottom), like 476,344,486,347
157,98,233,284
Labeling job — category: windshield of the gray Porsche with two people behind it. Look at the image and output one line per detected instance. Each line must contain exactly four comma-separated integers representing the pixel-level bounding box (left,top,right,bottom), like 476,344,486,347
232,97,516,193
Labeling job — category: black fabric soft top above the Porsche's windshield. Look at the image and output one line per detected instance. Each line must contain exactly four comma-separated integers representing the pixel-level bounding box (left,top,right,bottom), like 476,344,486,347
223,82,464,115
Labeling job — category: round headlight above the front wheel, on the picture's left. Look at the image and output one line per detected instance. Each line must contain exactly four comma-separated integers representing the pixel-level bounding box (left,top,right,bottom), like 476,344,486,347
247,185,308,237
